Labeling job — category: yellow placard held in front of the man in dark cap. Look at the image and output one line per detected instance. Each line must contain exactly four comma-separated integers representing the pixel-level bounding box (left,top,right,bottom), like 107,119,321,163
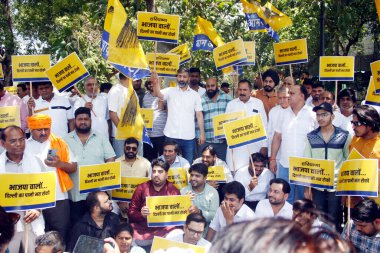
289,157,334,189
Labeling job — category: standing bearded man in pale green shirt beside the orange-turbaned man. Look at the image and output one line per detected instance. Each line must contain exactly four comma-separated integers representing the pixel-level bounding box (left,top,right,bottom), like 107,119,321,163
65,107,115,225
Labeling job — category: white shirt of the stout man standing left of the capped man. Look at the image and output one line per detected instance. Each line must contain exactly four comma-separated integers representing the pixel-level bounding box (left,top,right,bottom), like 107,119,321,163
275,105,318,168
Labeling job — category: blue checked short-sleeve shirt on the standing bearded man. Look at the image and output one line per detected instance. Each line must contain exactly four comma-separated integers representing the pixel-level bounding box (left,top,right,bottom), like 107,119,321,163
202,90,232,143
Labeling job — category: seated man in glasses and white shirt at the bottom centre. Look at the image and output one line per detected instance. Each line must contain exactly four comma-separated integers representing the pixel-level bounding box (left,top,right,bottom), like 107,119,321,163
166,213,211,252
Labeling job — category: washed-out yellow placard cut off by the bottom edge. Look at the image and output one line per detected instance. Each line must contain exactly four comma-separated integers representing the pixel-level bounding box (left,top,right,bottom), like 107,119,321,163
150,236,206,253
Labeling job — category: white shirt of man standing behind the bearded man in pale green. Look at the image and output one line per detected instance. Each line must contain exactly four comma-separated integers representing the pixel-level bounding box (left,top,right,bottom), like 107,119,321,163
73,94,109,136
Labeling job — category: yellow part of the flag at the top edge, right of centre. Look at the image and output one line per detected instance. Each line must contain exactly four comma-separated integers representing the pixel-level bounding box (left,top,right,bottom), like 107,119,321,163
240,0,293,32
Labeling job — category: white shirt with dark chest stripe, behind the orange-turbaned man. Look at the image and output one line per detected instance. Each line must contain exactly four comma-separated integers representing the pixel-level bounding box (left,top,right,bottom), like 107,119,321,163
34,94,74,138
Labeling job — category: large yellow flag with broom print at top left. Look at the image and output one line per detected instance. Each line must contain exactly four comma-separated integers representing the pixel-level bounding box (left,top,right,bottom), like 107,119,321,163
107,0,148,69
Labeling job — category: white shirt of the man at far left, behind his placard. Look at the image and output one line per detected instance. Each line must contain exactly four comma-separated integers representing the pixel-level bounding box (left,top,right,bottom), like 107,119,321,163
0,152,45,235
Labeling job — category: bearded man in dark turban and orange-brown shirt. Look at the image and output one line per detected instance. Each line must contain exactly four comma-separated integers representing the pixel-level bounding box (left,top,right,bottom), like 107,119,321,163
255,69,280,115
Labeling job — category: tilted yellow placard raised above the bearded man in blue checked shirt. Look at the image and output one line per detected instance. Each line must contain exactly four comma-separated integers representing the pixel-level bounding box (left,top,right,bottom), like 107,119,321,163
213,39,247,70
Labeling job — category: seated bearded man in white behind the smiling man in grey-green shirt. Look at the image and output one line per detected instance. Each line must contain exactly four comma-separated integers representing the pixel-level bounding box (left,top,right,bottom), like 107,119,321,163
193,145,233,202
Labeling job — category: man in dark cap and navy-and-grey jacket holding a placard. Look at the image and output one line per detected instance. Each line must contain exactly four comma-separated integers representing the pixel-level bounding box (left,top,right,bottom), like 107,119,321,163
304,102,351,230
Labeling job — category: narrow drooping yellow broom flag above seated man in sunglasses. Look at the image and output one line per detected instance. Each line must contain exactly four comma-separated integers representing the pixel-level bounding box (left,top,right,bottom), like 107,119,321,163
116,78,144,141
